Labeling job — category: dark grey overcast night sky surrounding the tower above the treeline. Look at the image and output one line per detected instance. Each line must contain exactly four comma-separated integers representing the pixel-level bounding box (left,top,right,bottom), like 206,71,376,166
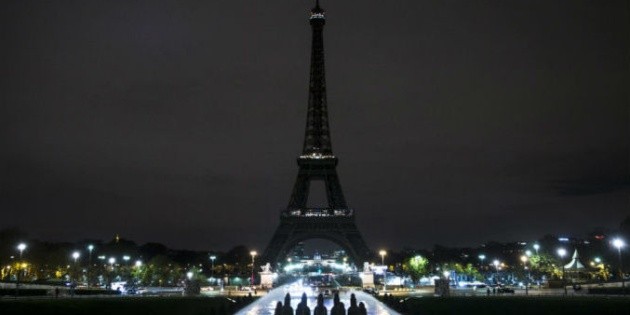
0,0,630,251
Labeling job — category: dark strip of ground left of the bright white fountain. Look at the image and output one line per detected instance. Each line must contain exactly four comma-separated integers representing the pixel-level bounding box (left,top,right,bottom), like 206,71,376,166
0,297,252,315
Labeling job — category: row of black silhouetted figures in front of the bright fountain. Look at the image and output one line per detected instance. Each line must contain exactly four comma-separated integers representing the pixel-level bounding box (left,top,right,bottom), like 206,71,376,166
273,293,367,315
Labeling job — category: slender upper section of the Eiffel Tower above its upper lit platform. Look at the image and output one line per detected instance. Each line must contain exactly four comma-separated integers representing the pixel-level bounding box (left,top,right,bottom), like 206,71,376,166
302,0,332,156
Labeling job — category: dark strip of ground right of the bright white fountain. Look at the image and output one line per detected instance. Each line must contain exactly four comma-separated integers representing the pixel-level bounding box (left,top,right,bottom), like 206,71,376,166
383,296,630,315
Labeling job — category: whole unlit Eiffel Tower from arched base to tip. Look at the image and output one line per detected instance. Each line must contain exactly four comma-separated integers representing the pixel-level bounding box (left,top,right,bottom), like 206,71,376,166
260,1,372,265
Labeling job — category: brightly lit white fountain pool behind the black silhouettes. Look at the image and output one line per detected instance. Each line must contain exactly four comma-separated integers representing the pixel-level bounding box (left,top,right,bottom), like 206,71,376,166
236,283,399,315
